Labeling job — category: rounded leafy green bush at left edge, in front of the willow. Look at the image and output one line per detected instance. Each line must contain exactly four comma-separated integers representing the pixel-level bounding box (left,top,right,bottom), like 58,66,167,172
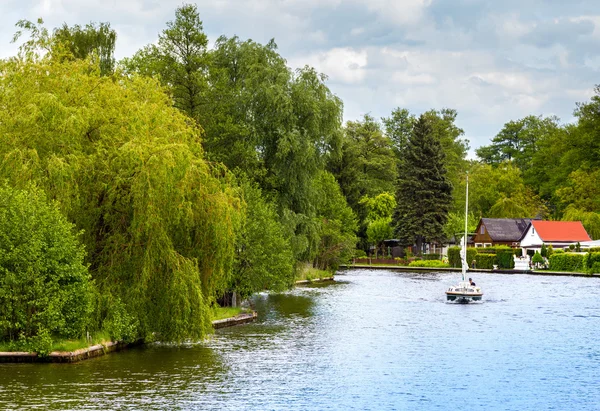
0,185,92,354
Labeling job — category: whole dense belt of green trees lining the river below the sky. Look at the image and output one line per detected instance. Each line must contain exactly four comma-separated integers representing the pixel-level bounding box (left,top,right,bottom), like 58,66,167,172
0,5,600,352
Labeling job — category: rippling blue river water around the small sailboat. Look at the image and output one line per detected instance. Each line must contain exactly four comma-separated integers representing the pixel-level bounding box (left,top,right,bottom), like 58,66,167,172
0,270,600,411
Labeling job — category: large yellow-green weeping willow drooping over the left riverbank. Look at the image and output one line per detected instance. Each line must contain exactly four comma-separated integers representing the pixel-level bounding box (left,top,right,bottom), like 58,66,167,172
0,38,243,341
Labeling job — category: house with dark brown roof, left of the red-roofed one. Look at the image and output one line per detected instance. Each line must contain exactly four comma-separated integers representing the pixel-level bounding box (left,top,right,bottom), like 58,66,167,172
473,218,531,248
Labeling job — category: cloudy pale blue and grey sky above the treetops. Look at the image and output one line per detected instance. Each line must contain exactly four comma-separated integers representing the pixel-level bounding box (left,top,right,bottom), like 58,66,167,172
0,0,600,154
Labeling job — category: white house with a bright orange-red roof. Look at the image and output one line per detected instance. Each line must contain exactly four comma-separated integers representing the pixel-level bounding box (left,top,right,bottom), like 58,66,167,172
521,220,592,254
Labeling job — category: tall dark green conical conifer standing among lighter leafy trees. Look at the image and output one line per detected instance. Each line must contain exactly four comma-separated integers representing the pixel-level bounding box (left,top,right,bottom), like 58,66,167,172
394,115,452,252
